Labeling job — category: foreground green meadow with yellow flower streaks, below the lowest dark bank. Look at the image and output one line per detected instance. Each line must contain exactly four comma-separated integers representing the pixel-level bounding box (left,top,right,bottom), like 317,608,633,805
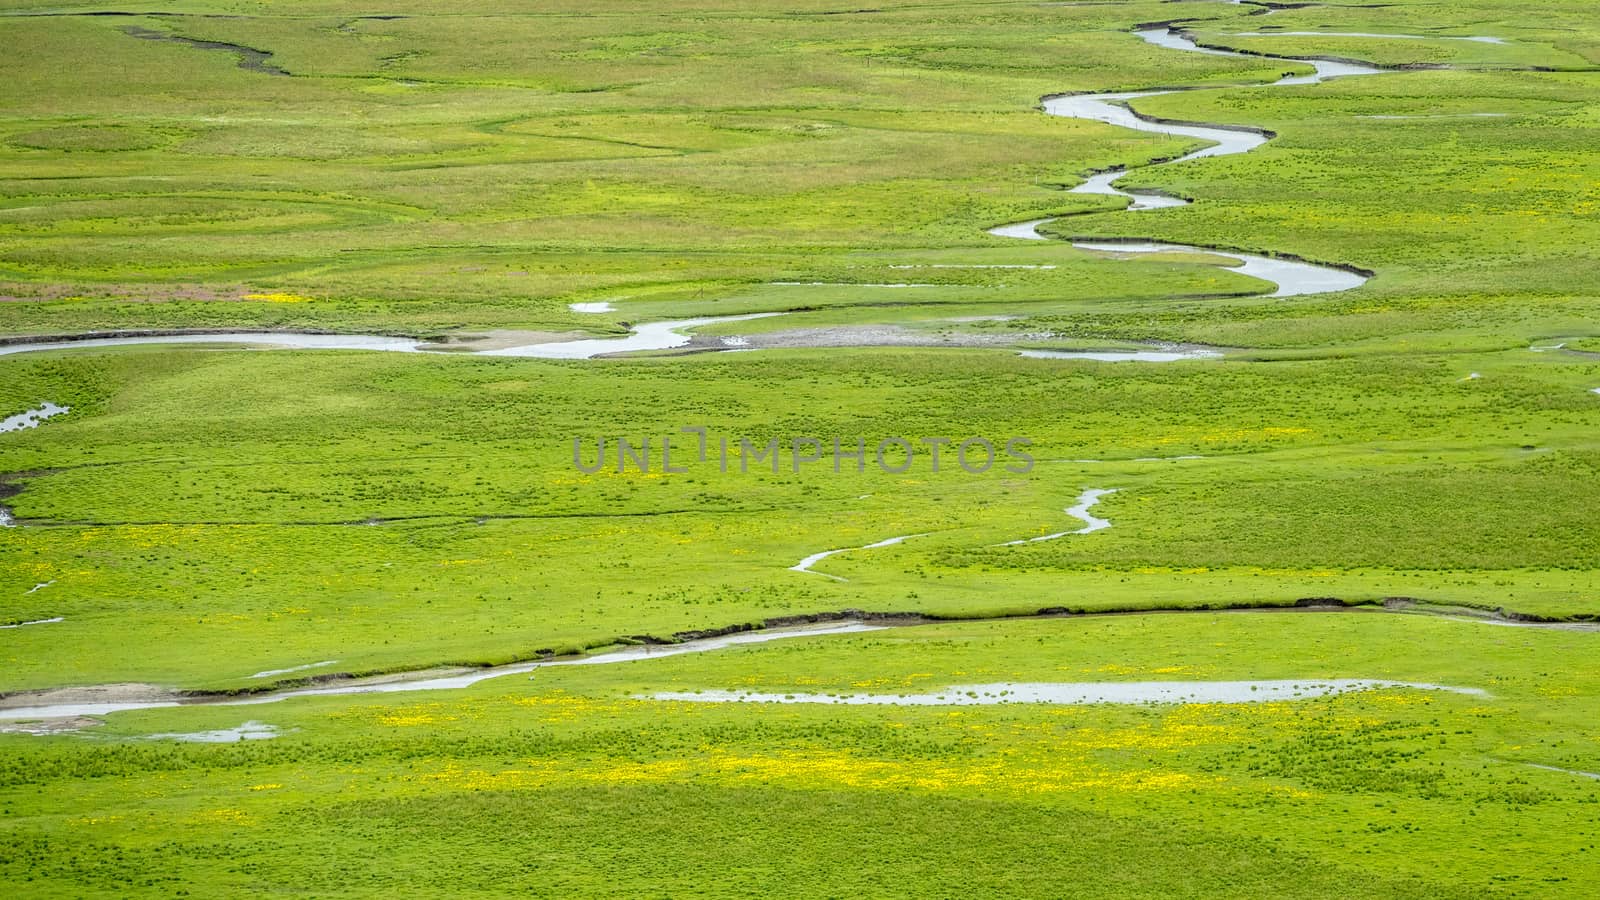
0,613,1600,897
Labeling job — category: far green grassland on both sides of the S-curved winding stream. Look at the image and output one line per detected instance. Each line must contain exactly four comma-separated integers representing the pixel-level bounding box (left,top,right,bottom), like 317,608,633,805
0,2,1600,346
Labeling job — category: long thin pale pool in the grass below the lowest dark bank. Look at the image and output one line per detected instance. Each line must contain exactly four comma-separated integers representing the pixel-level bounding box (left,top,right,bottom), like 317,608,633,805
646,679,1486,706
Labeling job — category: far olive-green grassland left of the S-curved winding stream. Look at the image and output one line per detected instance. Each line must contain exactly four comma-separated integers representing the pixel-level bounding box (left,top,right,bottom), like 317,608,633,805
0,3,1286,331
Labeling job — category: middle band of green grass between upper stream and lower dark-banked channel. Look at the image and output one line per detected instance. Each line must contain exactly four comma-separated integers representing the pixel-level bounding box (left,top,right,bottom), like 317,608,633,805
0,342,1600,689
